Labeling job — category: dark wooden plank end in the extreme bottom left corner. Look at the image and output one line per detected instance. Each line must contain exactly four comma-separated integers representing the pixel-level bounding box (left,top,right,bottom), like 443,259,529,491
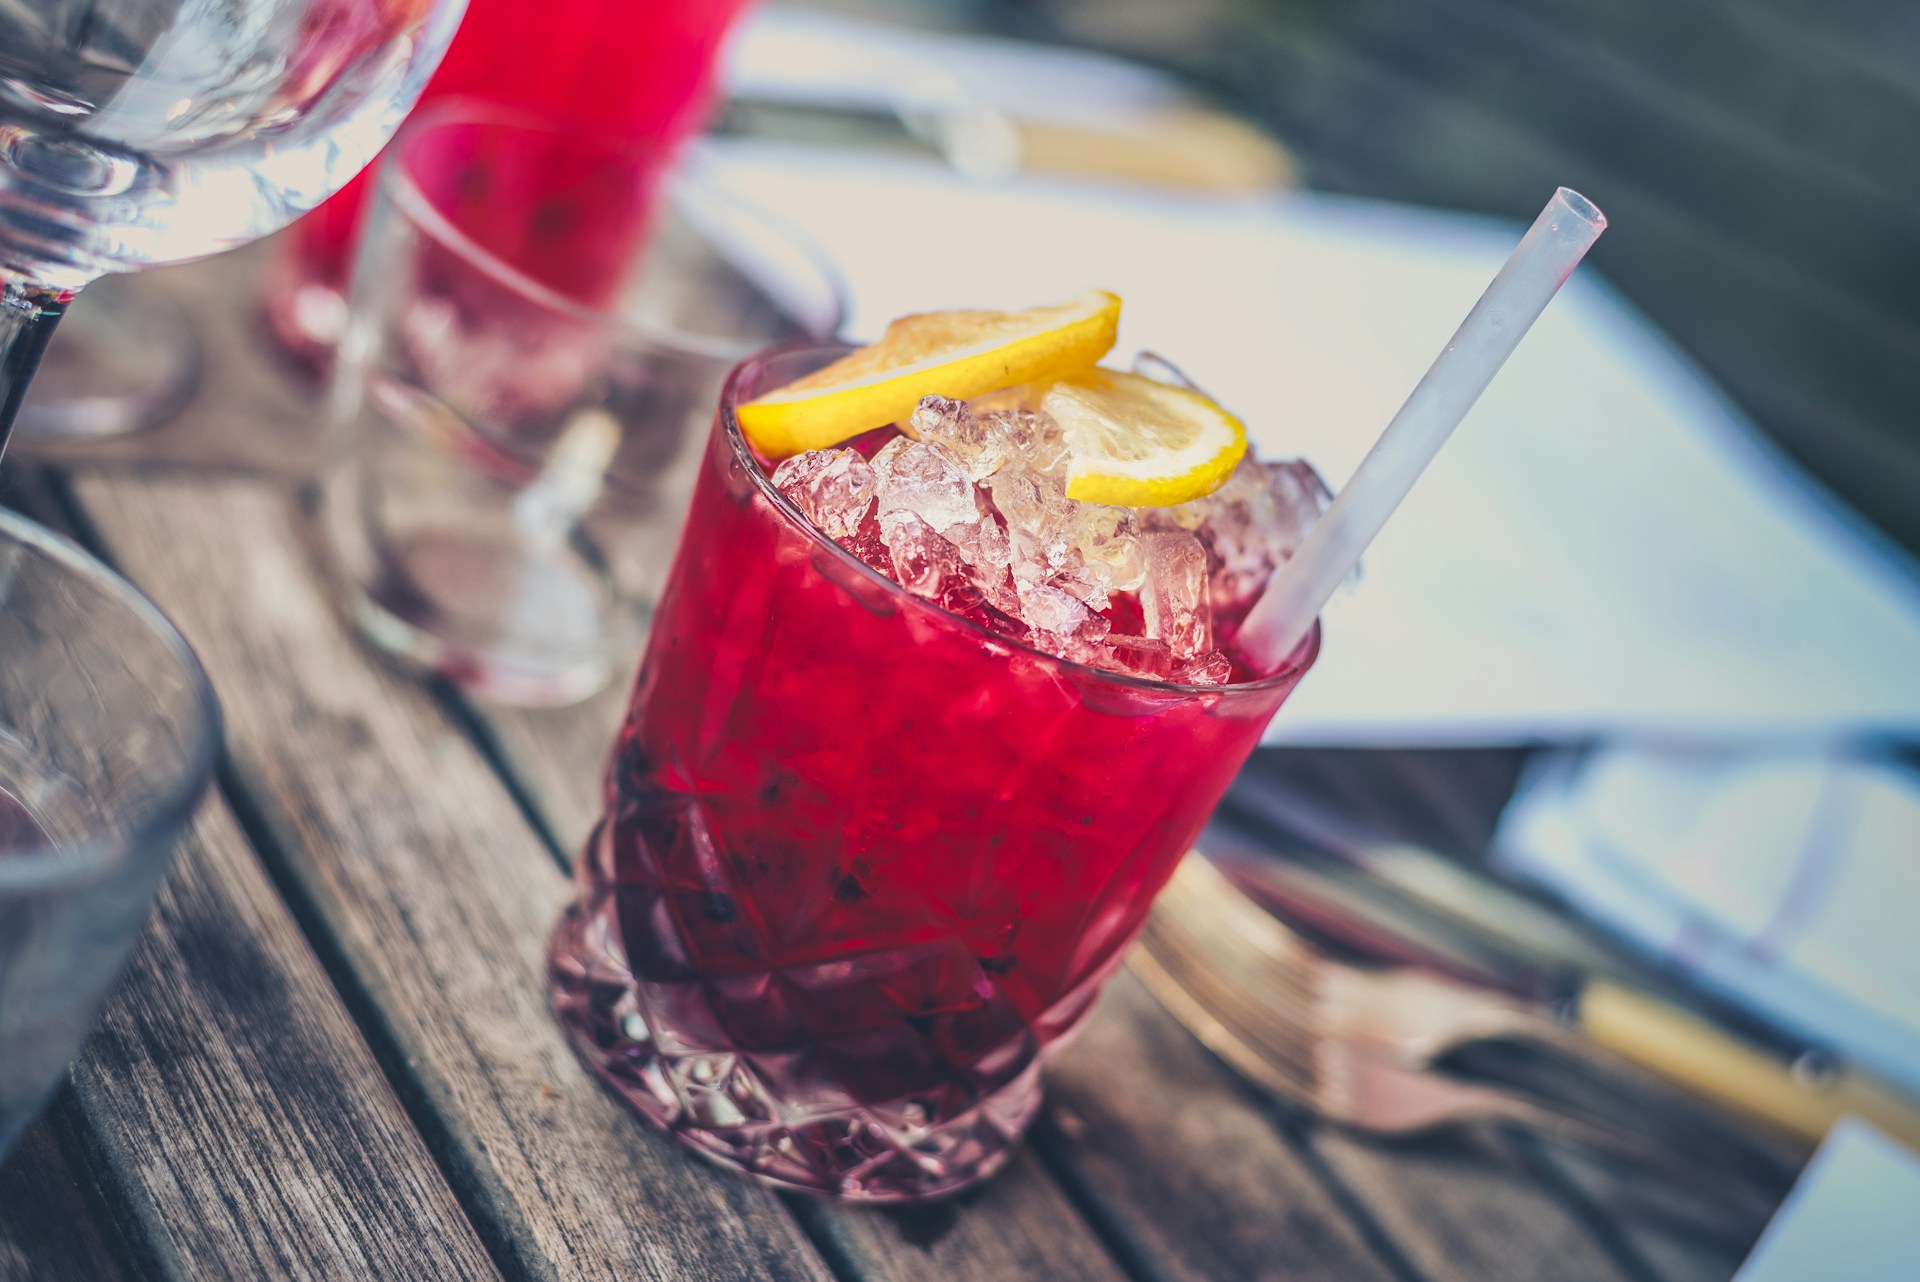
0,1119,127,1282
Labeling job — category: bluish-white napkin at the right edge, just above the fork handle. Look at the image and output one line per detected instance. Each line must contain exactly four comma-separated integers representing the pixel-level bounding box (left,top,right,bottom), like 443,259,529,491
1494,747,1920,1092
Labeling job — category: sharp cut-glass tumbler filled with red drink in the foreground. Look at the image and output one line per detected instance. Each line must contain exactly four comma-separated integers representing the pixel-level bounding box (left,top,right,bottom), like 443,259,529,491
549,345,1319,1201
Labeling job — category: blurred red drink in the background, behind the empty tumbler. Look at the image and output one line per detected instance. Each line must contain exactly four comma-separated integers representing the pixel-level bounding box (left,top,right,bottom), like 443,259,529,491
269,0,749,357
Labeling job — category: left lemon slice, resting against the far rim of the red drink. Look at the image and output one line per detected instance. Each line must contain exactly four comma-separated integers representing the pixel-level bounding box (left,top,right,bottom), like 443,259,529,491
739,290,1119,459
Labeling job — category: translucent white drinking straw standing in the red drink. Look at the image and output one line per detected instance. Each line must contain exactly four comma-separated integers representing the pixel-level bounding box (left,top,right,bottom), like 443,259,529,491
1236,186,1607,670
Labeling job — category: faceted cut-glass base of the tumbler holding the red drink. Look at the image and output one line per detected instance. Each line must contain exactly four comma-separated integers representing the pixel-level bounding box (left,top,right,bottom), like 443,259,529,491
549,902,1041,1201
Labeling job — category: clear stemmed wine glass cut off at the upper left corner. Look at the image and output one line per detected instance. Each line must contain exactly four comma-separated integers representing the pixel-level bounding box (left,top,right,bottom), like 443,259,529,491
0,0,465,451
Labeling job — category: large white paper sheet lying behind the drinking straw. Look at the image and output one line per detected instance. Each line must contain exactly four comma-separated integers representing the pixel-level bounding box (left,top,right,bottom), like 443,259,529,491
699,142,1920,745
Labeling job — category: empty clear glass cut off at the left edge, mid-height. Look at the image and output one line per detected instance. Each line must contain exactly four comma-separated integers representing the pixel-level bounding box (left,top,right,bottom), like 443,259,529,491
0,512,221,1159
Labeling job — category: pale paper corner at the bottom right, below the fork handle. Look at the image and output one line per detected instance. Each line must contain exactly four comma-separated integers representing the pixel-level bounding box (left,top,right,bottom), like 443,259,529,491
1734,1119,1920,1282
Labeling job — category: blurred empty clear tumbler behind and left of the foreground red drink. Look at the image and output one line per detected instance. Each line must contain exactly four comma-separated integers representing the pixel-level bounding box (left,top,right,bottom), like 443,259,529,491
323,104,843,704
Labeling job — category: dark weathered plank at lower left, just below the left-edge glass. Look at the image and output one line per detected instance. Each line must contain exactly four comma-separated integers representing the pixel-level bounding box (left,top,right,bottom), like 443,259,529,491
73,798,499,1282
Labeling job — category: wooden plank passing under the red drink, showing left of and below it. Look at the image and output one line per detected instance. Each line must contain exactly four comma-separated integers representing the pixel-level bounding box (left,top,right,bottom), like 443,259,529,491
474,694,1121,1282
